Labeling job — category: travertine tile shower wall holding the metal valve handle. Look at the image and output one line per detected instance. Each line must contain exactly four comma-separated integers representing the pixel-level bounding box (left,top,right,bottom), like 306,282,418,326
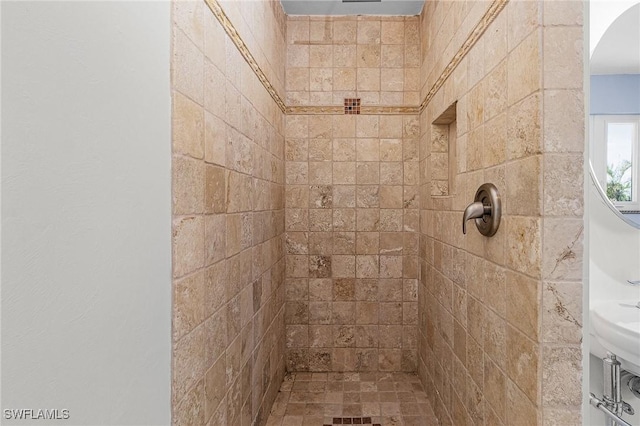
418,0,584,426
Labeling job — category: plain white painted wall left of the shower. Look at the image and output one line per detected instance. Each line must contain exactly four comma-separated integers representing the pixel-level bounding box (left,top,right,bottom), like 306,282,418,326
0,1,171,425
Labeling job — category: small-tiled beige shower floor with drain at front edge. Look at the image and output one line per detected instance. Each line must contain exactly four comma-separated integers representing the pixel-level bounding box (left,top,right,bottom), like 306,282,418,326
267,373,438,426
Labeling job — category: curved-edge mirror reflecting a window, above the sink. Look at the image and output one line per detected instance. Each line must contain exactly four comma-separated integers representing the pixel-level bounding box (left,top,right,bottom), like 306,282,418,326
589,0,640,228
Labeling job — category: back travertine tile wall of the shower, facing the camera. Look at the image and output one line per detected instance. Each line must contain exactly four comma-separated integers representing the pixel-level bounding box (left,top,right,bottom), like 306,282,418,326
285,17,419,371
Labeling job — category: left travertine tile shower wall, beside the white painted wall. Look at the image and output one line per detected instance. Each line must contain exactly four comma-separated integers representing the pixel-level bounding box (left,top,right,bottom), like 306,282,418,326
172,1,285,426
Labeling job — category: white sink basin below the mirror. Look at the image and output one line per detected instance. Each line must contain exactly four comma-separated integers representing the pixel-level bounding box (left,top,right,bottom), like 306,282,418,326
590,300,640,375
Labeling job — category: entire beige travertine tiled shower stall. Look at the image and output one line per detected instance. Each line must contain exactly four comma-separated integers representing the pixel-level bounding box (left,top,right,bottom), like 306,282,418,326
172,0,584,425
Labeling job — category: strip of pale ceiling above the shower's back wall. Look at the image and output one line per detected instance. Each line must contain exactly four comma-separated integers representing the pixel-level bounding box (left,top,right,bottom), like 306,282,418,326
281,0,424,16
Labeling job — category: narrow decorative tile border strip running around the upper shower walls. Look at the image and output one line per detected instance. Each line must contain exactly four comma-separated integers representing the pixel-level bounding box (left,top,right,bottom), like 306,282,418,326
204,0,509,115
